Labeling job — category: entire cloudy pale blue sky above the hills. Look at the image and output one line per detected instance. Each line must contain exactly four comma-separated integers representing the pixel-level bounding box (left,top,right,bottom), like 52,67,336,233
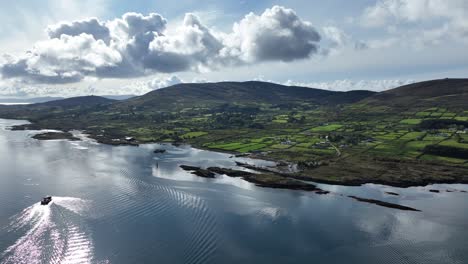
0,0,468,98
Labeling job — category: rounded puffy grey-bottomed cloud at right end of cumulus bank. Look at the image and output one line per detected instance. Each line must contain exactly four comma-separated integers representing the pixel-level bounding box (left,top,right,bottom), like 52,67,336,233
223,6,320,61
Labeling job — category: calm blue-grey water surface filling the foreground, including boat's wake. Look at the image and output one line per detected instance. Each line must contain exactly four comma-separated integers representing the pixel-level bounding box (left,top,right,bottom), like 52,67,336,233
0,120,468,264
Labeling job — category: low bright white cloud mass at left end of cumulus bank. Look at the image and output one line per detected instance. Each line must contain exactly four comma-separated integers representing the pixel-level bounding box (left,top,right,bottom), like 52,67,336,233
0,33,122,83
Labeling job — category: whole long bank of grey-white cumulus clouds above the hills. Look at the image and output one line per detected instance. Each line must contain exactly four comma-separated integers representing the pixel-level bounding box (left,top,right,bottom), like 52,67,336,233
0,6,320,84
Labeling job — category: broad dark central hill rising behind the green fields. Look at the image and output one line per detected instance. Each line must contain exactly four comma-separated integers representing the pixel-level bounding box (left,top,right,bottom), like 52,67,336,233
117,81,373,109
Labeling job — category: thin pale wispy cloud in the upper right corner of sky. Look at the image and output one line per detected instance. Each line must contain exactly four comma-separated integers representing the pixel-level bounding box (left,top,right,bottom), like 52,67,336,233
361,0,468,50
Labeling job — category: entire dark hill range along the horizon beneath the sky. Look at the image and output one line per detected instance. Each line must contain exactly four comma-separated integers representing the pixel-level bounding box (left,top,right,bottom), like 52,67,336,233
4,78,468,109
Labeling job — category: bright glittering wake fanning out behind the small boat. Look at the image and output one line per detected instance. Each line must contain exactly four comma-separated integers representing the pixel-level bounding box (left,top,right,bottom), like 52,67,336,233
0,197,93,264
